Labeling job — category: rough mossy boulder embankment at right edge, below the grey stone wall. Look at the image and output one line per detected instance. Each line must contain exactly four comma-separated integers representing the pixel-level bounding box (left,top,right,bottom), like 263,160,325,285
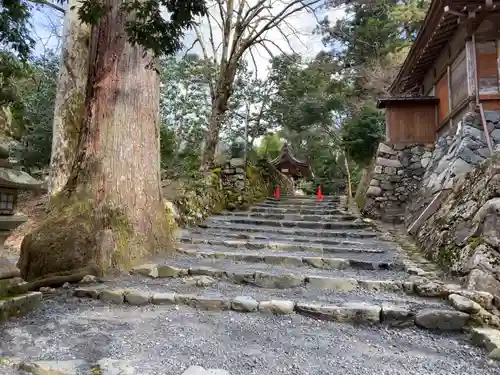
416,151,500,298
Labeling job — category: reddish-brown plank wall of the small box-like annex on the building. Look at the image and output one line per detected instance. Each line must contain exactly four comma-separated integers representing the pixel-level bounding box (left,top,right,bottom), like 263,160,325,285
385,103,436,144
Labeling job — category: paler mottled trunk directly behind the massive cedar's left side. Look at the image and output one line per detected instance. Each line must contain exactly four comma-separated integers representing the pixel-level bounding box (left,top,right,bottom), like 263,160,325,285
48,0,90,195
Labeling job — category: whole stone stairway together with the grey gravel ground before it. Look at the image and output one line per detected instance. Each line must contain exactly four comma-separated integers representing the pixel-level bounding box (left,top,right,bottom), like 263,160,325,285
0,197,500,375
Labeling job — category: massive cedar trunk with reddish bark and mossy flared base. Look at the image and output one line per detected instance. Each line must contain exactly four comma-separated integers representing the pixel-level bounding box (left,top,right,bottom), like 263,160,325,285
18,0,172,281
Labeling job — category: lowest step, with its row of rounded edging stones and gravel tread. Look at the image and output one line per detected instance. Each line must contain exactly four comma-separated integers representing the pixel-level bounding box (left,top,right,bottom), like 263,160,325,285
73,277,469,331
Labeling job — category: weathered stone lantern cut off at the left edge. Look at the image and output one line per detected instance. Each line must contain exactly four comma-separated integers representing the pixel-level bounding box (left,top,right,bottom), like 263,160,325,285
0,145,42,280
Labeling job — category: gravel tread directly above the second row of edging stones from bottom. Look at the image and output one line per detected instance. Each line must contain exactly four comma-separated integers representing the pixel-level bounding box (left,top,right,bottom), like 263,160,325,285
157,255,409,280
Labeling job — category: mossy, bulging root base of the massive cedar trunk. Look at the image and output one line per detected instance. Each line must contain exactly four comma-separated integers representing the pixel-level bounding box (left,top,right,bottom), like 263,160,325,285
19,188,173,281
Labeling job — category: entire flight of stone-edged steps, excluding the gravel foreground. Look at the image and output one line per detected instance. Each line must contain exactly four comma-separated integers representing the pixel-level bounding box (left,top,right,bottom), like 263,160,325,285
75,197,500,331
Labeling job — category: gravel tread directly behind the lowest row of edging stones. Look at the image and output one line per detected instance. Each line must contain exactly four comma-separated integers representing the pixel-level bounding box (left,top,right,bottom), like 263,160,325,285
101,275,449,310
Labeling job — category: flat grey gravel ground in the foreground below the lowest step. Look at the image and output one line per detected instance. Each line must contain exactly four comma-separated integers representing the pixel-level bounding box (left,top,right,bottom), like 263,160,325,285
0,299,500,375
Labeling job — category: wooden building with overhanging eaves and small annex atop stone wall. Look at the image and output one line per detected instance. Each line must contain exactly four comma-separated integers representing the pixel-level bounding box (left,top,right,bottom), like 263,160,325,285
378,0,500,150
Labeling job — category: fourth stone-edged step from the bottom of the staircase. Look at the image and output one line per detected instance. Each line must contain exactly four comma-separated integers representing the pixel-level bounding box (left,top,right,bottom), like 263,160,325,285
180,236,398,262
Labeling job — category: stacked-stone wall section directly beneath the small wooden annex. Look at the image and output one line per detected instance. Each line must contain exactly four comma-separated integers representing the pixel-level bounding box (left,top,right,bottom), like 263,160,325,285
363,143,433,222
